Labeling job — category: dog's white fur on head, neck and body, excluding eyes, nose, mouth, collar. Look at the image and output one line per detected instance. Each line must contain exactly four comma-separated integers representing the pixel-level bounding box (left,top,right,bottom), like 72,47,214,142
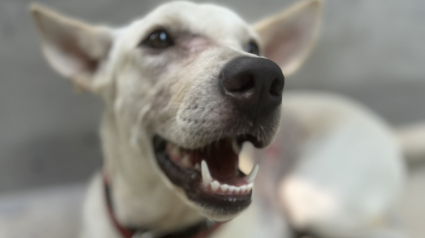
28,0,403,238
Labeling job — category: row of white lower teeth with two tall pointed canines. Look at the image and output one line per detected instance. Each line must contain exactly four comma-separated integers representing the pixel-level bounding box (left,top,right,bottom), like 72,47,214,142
201,160,259,194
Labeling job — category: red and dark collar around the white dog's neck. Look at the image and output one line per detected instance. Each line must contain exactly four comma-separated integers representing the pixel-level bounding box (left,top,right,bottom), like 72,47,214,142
103,174,223,238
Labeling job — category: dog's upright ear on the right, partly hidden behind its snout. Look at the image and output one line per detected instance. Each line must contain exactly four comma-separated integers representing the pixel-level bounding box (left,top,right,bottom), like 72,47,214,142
254,0,322,76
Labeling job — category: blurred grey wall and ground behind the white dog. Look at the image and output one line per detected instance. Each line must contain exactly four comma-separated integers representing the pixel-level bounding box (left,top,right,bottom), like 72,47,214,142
0,0,425,238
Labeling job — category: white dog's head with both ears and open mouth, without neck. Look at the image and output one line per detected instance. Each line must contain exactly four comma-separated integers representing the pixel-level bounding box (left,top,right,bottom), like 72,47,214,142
32,0,320,220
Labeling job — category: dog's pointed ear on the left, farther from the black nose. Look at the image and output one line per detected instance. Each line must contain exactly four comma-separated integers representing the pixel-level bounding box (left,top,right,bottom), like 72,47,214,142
30,4,112,92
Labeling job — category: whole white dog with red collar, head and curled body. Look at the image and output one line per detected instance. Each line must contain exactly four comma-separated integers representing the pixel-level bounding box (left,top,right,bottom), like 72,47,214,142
31,0,404,238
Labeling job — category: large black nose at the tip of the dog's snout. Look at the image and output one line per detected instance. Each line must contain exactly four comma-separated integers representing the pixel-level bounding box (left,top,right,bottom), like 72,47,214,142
220,56,285,122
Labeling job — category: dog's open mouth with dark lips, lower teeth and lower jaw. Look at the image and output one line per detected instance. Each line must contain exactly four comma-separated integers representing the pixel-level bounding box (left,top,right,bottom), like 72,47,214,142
153,135,260,215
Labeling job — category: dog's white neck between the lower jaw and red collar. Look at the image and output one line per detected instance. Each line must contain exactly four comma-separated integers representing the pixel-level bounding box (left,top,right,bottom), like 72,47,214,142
101,110,204,231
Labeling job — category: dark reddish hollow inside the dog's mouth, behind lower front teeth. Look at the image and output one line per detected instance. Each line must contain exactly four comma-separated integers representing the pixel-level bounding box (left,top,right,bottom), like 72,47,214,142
203,139,239,182
